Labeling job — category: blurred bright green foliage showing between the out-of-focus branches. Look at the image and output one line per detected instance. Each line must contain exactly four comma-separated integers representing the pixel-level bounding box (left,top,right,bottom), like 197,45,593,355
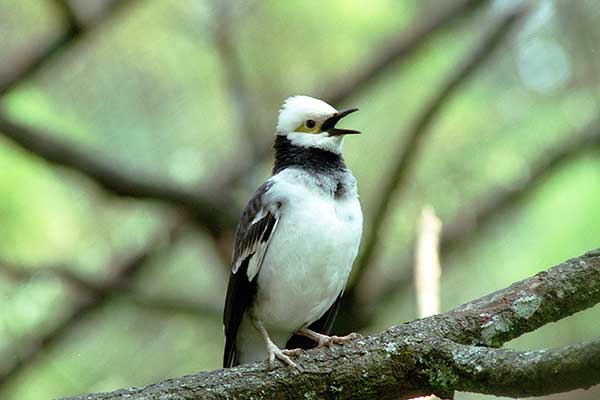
0,0,600,400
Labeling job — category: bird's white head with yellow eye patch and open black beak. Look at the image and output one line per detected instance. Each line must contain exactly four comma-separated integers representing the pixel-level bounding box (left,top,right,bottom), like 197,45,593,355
277,96,360,153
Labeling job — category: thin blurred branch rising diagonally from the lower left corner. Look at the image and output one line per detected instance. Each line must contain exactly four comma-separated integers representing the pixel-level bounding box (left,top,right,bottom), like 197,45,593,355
0,221,181,389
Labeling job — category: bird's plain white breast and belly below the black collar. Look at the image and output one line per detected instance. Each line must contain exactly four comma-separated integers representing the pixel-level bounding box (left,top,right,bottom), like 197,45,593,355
252,191,362,334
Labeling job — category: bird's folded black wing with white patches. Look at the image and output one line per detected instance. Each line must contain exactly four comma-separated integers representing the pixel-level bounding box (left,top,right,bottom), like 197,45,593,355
223,182,279,367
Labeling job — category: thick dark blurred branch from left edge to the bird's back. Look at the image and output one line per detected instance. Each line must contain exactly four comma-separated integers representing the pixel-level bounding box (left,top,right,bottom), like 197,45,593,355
0,113,237,236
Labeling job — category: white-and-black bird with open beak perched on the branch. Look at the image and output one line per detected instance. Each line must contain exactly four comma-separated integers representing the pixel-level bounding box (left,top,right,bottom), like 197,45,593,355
223,95,363,369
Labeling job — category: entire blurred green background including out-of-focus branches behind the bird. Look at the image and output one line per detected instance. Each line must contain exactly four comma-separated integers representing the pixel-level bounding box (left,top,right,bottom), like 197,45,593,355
0,0,600,400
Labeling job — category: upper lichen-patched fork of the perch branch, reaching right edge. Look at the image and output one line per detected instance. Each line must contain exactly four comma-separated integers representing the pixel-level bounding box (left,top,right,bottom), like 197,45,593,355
434,249,600,347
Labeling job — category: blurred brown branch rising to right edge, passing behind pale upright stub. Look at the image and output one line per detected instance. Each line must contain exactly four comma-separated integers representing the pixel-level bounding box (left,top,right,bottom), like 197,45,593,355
366,118,600,321
